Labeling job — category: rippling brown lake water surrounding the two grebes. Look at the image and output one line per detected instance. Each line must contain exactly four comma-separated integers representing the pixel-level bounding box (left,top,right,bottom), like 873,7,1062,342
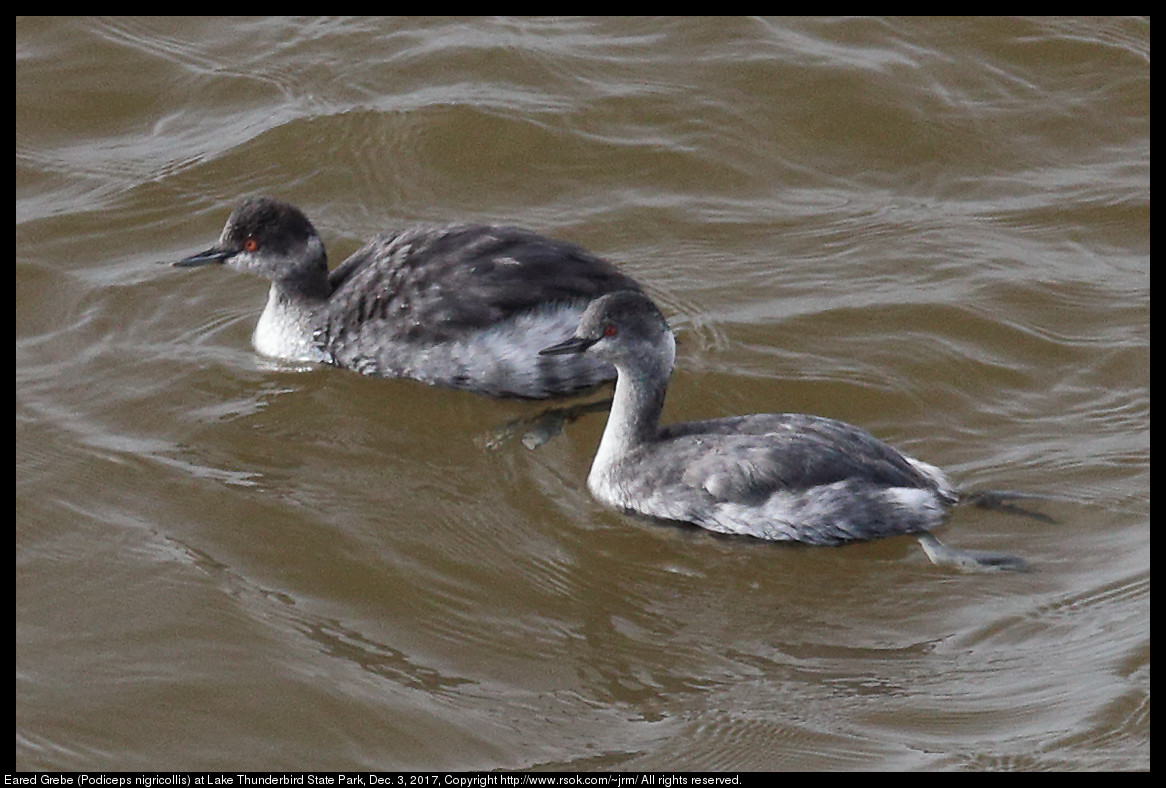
15,19,1150,769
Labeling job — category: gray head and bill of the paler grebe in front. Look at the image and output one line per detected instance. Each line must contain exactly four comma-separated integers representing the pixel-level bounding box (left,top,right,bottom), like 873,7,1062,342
540,290,676,372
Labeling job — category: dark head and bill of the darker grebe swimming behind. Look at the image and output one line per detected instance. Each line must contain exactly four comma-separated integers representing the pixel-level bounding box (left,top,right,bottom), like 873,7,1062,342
173,196,328,291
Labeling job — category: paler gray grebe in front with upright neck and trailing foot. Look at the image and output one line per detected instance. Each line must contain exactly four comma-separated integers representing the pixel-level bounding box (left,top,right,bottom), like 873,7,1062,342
541,291,1040,569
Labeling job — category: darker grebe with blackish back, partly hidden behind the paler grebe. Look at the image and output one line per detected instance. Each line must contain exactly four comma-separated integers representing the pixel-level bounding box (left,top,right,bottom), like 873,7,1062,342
171,196,641,397
